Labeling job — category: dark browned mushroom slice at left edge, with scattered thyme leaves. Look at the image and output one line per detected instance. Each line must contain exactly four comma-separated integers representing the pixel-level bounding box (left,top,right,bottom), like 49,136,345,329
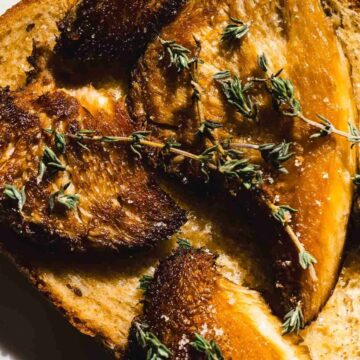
0,76,185,251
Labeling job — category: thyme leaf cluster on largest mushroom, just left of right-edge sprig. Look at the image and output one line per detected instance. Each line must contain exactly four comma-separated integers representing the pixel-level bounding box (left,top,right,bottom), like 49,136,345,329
218,76,258,120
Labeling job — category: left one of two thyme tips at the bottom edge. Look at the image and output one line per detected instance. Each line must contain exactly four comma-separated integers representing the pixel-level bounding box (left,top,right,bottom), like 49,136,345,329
134,322,171,360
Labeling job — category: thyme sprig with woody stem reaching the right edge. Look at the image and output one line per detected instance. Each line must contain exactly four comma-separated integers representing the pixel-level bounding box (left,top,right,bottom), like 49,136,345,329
255,54,360,146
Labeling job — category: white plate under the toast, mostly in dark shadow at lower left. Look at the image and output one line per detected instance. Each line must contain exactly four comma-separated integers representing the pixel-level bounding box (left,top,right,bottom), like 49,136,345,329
0,0,108,360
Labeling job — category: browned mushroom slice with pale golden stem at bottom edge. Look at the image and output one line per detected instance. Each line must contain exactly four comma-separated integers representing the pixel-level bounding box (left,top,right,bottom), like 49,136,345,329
126,249,309,360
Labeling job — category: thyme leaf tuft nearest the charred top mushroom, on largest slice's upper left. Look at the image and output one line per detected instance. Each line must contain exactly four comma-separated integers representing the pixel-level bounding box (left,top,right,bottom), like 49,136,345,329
159,39,191,73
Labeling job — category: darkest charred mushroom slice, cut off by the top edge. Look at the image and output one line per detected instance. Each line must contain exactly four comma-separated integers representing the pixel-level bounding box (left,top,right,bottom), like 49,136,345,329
57,0,186,61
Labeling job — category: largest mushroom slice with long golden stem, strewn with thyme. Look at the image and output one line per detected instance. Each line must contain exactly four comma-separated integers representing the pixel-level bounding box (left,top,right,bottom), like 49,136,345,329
129,0,358,322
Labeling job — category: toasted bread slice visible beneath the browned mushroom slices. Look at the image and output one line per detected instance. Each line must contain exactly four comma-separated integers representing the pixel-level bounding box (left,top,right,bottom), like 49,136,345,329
0,0,360,359
